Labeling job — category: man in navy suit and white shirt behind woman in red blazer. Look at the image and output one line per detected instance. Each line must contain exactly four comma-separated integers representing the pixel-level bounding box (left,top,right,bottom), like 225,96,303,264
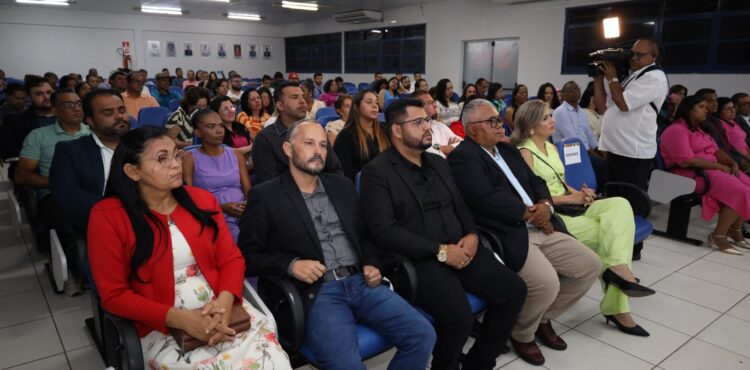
49,90,130,233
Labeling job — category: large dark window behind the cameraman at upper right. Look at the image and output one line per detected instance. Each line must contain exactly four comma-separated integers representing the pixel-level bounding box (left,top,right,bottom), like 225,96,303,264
561,0,750,74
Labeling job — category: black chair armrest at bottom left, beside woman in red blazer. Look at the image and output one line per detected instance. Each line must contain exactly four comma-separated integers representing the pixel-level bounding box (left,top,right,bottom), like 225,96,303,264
104,312,144,370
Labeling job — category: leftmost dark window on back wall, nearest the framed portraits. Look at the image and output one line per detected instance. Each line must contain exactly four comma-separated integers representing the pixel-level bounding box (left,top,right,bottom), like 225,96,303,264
284,33,341,73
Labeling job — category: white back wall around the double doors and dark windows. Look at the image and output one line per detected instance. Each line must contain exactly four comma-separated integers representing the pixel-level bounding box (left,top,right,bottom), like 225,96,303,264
288,0,750,95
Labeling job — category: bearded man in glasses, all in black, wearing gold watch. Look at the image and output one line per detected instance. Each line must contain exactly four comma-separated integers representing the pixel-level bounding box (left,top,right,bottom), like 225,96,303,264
360,99,526,370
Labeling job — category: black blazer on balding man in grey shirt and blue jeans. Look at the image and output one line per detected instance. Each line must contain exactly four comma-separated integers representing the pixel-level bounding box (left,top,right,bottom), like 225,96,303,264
237,171,379,312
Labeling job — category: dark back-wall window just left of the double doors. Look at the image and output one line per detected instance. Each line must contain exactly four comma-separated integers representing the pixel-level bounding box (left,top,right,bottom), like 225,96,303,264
344,24,425,73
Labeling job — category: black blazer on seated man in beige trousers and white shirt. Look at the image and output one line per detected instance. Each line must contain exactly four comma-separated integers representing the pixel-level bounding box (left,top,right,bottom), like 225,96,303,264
448,136,566,271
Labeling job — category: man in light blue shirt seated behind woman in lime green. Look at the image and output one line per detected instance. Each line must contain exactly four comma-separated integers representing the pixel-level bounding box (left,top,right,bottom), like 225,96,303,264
556,81,607,189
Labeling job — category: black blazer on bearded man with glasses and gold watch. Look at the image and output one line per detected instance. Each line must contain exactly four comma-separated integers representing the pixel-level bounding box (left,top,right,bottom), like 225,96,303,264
360,147,477,261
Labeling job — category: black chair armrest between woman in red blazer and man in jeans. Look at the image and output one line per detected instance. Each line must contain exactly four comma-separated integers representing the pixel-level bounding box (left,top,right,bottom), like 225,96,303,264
258,277,305,352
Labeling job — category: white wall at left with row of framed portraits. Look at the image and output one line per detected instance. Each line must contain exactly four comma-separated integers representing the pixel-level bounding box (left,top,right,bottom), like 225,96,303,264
0,6,284,78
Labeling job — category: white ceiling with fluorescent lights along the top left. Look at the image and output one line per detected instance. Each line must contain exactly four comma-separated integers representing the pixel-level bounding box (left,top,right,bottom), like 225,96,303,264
0,0,447,24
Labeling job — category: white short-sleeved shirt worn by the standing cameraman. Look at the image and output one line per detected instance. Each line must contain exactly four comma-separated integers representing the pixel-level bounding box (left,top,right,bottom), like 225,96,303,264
599,66,669,159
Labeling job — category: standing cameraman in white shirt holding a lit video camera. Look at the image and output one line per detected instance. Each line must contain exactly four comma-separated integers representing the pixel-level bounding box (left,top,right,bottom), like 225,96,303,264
594,37,669,198
